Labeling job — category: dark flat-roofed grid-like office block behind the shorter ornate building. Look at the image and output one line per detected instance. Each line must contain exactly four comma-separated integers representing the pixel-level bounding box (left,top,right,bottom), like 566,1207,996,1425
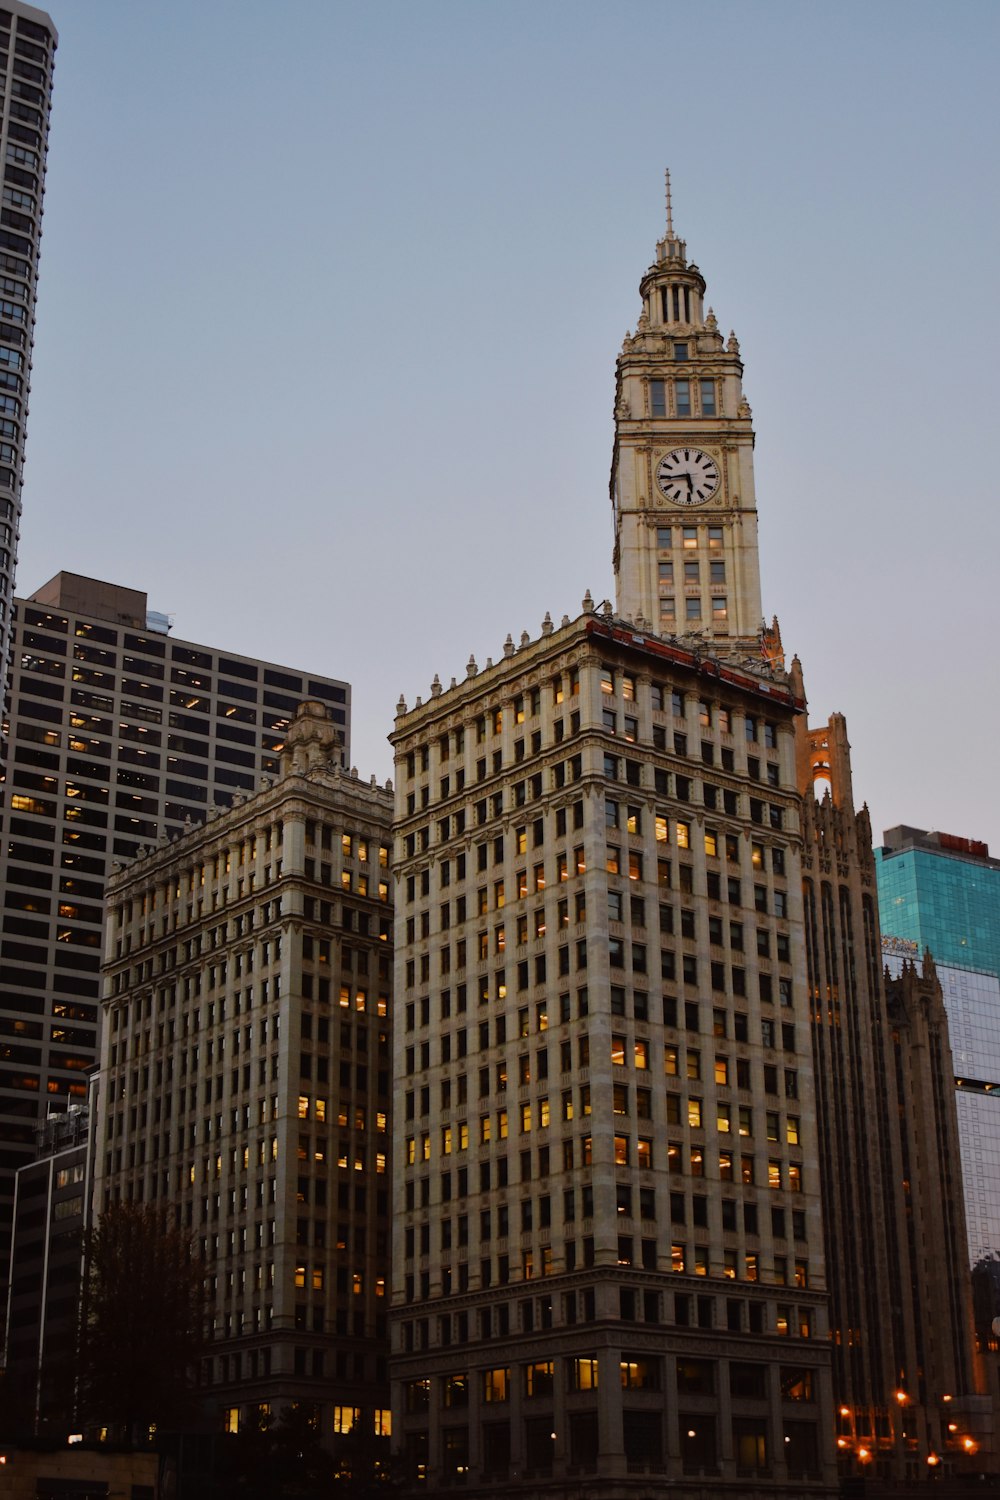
0,573,351,1304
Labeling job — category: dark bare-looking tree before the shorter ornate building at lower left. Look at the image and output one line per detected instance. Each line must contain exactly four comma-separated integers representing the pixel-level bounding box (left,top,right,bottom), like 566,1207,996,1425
81,1203,205,1439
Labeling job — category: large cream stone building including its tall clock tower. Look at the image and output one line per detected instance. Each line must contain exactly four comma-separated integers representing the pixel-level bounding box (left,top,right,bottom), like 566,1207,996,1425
391,193,835,1500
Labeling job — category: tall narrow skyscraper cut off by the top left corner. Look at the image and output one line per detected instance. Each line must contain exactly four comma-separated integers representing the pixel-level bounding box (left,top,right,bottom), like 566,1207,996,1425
0,0,58,683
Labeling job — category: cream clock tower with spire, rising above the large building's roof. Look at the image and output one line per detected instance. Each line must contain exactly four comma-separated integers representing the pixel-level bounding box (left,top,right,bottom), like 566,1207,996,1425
610,173,762,656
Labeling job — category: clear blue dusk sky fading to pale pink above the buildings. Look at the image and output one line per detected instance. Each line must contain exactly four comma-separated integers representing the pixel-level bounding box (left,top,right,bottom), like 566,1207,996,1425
18,0,1000,855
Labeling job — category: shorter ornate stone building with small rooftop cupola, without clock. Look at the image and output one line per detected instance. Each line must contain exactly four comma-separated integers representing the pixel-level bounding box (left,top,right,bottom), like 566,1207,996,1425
94,702,391,1446
